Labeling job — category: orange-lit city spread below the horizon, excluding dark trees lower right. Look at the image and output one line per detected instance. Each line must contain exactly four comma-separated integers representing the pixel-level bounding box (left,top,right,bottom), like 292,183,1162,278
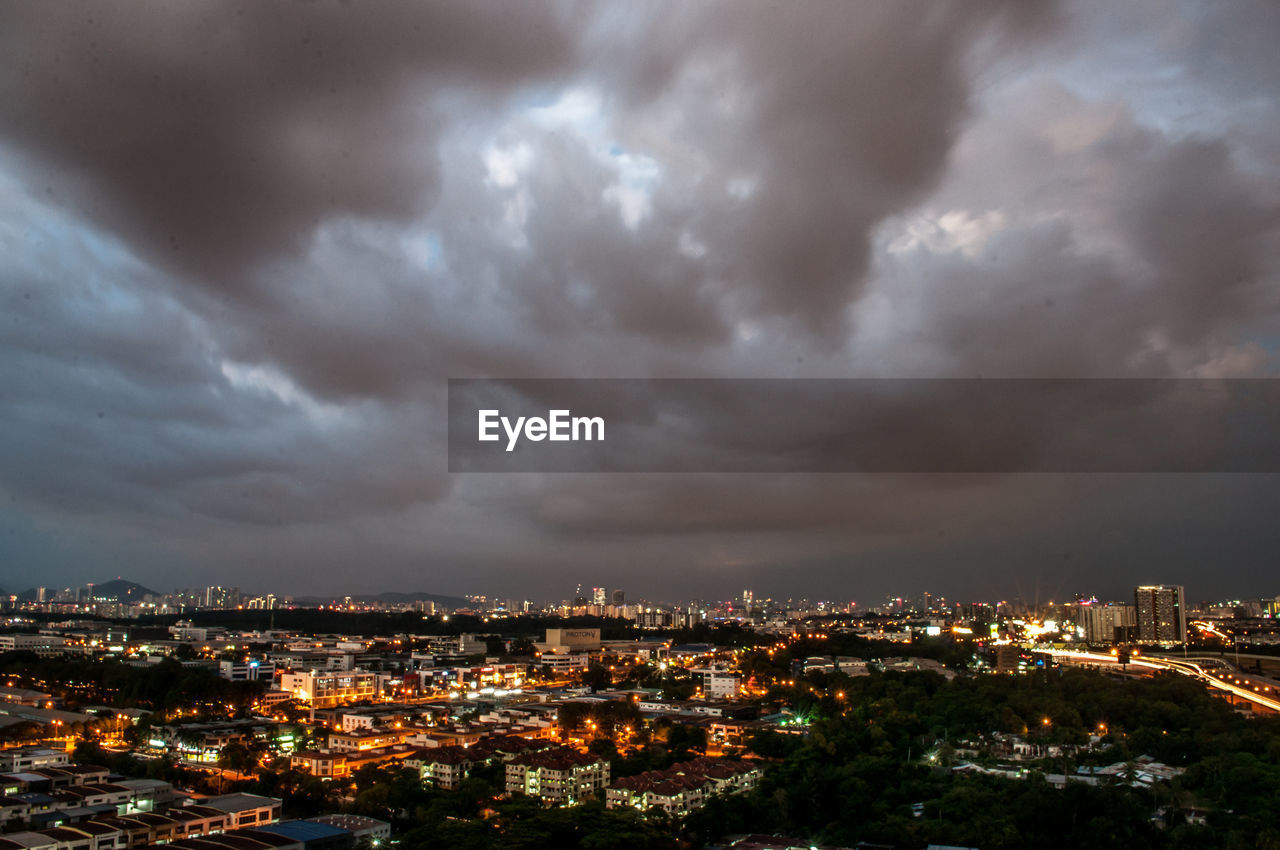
0,580,1280,847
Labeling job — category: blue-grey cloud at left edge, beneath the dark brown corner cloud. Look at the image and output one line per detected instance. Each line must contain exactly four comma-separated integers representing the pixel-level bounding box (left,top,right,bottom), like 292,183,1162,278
0,185,448,527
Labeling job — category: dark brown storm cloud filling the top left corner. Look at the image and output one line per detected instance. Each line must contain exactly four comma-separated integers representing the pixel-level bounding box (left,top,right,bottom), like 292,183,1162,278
0,3,572,288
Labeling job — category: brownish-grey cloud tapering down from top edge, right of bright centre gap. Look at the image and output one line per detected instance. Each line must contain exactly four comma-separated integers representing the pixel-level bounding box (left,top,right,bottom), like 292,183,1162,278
586,3,1052,343
